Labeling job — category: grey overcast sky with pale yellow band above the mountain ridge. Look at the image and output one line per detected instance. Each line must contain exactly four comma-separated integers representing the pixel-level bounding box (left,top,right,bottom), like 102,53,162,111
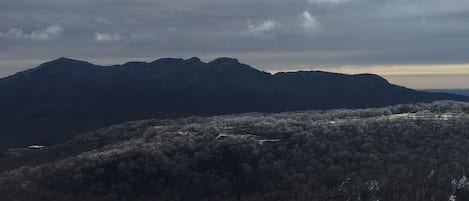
0,0,469,88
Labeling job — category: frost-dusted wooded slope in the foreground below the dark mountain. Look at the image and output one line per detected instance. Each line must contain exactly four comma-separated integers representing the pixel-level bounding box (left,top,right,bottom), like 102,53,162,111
0,102,469,201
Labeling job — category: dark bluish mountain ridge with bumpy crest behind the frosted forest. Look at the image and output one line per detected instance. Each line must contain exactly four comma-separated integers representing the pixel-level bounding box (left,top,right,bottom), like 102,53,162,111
0,57,468,148
